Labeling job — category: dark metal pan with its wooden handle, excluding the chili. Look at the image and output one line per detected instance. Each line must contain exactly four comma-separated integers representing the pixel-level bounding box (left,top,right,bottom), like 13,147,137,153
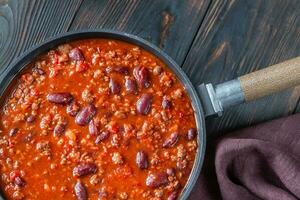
0,29,300,200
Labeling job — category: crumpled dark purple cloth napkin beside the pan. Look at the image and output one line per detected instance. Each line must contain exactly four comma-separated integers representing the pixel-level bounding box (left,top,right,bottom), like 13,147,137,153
190,114,300,200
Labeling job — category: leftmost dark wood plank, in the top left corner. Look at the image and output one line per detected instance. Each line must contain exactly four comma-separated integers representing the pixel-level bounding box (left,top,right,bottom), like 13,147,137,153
0,0,82,70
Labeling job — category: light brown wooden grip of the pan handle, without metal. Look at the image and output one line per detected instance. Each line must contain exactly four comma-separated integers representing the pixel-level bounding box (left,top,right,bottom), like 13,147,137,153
239,57,300,101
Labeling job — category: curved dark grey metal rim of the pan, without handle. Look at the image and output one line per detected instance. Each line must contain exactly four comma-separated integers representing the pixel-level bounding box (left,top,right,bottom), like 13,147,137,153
0,29,206,200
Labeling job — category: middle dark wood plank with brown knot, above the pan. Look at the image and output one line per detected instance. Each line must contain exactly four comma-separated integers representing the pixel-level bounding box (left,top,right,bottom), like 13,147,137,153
71,0,210,64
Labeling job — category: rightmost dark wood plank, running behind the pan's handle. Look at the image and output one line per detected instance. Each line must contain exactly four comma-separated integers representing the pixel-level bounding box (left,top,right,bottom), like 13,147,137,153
183,0,300,135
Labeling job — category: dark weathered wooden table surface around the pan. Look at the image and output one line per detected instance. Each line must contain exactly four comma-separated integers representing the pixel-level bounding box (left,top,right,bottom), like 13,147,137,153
0,0,300,199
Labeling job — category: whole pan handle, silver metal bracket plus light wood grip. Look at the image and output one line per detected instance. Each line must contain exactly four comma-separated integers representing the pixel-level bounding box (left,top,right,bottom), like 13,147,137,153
198,57,300,116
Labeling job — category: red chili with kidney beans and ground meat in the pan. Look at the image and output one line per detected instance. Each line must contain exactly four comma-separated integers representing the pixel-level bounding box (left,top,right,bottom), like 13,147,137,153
0,39,198,200
